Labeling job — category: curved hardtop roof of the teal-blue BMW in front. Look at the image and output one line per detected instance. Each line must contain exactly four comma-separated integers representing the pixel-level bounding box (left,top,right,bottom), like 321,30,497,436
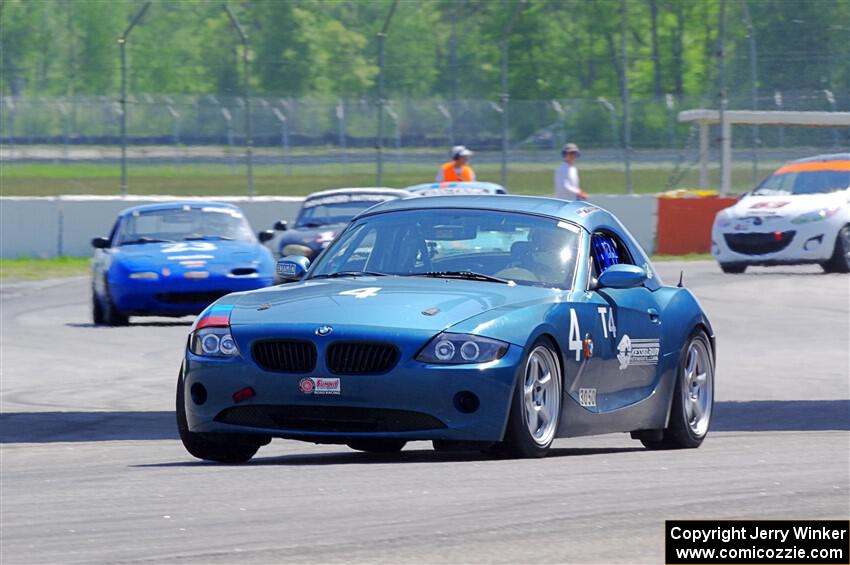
355,194,621,231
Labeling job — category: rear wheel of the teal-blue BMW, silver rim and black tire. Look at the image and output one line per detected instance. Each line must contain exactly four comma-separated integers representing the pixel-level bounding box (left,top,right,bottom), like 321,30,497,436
641,330,714,449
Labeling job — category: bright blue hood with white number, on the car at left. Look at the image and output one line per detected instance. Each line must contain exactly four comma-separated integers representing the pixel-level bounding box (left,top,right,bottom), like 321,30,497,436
114,241,271,268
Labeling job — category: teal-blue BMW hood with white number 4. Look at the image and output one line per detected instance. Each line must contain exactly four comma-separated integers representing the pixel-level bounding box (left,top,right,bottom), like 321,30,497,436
230,276,564,332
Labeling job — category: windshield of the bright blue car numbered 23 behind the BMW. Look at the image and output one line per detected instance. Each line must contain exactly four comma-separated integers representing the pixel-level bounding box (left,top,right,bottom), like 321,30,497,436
118,206,254,245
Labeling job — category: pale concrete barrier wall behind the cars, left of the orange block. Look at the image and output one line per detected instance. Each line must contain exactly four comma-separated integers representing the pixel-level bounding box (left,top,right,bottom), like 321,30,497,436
0,195,658,258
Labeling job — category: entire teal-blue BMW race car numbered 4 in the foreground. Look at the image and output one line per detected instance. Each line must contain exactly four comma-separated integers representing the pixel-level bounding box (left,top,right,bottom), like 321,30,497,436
177,196,715,462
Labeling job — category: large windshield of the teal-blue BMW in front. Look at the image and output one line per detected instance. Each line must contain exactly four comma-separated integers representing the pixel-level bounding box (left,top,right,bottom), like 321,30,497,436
310,209,579,288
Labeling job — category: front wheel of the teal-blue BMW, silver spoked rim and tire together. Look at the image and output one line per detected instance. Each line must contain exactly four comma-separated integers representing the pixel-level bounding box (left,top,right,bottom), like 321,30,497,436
500,338,563,457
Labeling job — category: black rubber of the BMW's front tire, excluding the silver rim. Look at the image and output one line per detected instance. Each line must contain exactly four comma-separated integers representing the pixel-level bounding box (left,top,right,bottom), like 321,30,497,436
494,337,564,459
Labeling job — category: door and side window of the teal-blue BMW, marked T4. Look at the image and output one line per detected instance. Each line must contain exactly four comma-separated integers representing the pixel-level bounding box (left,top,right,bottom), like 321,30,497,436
590,231,662,409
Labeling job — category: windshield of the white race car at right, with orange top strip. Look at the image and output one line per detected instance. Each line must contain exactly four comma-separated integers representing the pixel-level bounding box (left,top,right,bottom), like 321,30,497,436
753,161,850,196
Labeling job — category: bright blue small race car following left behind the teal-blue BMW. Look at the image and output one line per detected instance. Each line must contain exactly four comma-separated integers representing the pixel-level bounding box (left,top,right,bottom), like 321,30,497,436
92,202,274,325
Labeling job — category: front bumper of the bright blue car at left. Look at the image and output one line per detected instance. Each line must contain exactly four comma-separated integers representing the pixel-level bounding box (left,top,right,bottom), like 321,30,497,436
109,274,273,316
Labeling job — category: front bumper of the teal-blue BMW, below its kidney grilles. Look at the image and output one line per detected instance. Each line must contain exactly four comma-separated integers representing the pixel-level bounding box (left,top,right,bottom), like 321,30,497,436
184,345,523,443
